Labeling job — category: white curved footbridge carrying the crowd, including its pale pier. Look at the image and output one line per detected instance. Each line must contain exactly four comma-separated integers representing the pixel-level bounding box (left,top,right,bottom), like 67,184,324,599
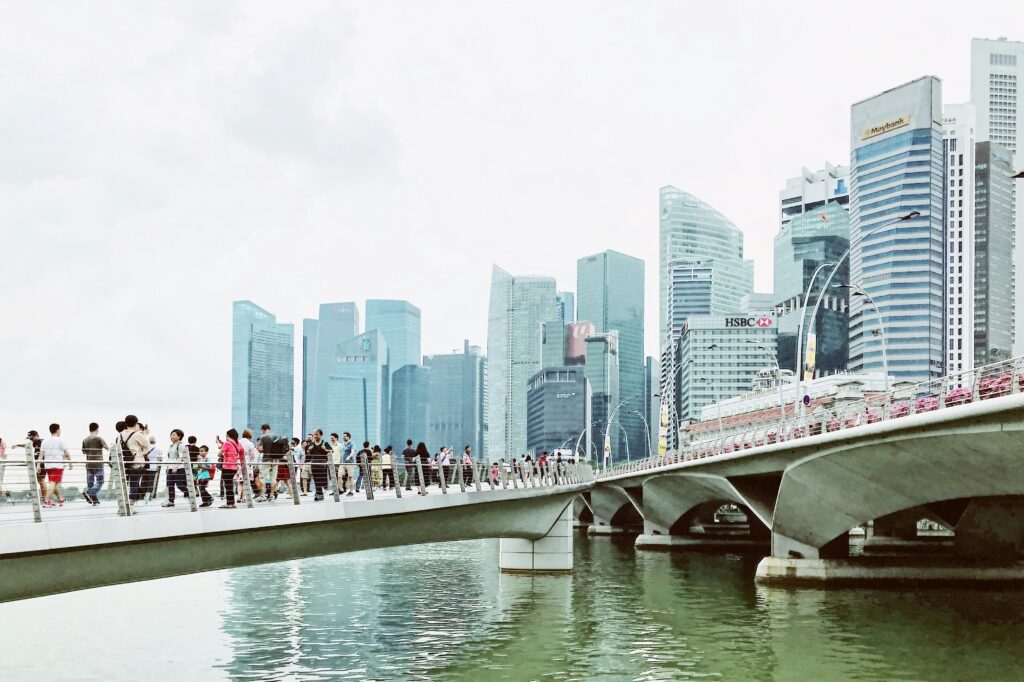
0,459,594,602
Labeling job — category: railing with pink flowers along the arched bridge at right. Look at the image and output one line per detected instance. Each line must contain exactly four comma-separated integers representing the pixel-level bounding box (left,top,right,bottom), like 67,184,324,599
598,357,1024,478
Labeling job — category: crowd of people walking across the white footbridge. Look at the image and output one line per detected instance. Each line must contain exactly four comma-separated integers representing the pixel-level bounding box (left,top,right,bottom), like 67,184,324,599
0,415,573,509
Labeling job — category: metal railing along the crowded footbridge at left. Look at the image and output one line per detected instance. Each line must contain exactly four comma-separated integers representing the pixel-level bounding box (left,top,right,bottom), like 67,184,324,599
0,443,595,522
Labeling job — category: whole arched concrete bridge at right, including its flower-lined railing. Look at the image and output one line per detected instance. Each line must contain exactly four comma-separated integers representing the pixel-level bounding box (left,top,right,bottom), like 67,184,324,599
584,359,1024,582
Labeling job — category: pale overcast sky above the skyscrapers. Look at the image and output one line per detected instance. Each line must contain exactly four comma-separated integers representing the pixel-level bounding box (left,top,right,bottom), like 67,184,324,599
0,0,1024,442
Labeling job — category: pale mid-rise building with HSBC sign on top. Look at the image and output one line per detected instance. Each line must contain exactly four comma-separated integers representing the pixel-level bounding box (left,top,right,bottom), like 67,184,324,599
670,312,777,425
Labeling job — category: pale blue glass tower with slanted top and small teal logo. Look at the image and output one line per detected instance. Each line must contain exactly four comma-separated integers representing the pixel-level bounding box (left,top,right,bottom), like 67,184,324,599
316,329,388,444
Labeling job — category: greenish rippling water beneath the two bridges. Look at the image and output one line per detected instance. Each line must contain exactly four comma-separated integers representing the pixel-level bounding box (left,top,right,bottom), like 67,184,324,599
0,539,1024,681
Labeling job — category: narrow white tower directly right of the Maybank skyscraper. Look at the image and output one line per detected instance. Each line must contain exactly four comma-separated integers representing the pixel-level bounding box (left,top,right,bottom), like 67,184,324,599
942,102,976,375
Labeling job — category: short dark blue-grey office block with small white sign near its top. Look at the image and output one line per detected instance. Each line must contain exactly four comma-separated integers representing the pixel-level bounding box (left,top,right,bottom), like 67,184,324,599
526,367,593,459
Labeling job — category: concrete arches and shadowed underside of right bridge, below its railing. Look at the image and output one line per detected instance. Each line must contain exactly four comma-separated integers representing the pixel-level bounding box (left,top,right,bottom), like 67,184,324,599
590,396,1024,583
